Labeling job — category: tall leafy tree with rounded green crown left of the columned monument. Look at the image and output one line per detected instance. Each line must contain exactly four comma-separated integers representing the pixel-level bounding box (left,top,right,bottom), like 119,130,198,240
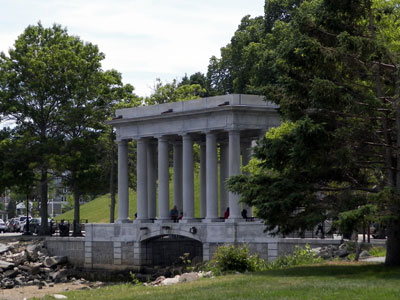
0,23,137,234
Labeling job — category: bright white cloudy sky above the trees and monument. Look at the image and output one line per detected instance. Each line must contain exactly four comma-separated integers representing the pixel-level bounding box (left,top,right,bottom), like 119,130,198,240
0,0,264,96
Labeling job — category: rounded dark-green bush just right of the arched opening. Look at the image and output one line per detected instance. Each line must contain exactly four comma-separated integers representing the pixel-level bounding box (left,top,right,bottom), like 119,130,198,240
206,245,266,275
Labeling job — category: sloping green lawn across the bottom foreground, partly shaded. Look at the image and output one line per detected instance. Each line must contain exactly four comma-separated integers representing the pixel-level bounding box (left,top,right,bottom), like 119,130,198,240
36,263,400,300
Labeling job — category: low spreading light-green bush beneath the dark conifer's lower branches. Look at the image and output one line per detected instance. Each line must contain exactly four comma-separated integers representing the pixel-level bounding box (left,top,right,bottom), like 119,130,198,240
267,245,323,270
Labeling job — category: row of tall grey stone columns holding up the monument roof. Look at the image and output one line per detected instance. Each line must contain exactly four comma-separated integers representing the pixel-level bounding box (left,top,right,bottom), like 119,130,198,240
117,130,251,223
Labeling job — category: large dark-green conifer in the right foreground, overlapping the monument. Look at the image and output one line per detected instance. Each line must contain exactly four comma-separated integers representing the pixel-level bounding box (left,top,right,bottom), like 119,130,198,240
230,0,400,265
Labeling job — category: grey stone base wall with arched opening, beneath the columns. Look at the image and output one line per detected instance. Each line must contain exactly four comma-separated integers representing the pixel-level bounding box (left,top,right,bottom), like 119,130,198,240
46,222,340,271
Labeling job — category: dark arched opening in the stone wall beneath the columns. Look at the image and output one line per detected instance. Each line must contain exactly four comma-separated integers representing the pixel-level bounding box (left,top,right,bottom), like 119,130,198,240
143,234,203,266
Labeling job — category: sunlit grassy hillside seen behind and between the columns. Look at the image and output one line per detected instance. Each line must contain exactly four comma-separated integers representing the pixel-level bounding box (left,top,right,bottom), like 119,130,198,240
55,168,206,223
